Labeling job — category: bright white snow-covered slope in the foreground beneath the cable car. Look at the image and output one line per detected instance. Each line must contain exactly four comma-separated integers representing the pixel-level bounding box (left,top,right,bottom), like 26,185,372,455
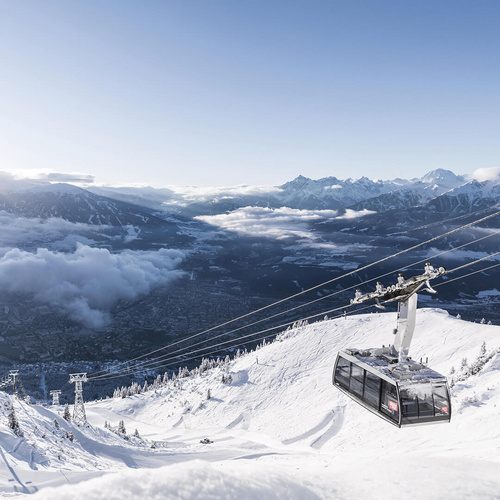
0,309,500,499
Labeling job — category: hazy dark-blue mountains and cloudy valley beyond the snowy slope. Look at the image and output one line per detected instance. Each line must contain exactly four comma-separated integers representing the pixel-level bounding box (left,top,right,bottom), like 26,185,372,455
0,170,500,368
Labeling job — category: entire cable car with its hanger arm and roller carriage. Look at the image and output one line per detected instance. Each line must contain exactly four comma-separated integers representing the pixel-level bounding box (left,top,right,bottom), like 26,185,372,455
333,264,451,427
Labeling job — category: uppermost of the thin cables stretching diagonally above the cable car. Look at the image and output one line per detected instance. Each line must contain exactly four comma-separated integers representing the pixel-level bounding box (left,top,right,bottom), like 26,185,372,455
90,211,500,376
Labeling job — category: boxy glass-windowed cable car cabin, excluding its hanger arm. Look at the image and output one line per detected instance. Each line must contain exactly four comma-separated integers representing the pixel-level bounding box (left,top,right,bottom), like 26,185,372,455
333,347,451,427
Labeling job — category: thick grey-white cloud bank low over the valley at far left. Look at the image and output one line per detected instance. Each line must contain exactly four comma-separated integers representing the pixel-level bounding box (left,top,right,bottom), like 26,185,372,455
0,244,184,329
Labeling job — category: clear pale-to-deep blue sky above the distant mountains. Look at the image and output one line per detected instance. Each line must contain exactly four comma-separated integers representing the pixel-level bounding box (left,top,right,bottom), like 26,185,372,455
0,0,500,186
